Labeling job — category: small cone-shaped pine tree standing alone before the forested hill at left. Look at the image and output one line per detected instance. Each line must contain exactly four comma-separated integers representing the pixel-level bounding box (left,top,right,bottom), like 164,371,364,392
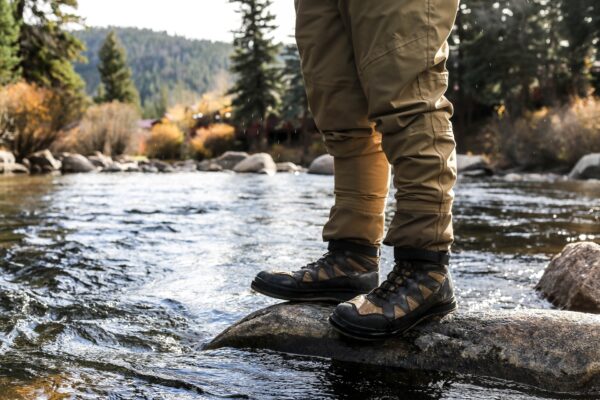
98,31,140,105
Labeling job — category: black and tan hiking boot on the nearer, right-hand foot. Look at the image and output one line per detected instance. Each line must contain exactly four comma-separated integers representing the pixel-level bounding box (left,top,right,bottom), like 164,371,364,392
329,248,457,340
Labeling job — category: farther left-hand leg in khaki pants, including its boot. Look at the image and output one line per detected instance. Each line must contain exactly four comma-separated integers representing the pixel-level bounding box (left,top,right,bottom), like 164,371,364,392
252,0,390,301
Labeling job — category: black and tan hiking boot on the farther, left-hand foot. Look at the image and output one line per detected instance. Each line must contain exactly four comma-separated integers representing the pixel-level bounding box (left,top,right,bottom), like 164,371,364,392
252,240,379,303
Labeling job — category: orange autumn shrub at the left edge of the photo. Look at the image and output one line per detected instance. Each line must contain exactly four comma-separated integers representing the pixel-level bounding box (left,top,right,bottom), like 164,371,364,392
0,82,62,161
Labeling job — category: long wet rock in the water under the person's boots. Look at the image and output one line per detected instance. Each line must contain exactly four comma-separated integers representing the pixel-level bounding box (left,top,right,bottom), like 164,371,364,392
206,303,600,393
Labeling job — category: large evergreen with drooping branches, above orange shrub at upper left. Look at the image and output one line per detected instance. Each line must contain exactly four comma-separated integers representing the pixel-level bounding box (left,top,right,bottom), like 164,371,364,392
14,0,88,129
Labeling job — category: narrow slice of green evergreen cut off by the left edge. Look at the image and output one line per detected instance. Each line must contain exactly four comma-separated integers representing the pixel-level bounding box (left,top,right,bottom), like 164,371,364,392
0,0,20,85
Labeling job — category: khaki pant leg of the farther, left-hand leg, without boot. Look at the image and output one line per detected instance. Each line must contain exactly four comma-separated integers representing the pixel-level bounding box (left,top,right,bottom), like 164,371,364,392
296,0,390,245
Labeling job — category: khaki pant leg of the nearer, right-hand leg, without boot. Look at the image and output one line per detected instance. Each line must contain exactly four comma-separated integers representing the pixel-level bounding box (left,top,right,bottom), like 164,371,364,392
338,0,458,251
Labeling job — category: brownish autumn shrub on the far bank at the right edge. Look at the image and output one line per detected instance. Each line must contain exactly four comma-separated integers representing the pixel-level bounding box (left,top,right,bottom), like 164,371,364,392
488,98,600,169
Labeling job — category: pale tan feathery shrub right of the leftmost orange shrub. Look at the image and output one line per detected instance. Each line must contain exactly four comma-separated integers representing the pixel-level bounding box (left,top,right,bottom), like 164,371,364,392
70,102,140,156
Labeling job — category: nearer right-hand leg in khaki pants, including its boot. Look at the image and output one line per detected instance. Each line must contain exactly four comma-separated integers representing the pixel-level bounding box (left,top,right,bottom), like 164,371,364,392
332,0,458,337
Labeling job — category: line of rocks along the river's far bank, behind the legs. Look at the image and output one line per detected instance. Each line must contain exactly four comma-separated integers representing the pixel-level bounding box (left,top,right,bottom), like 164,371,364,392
0,150,600,182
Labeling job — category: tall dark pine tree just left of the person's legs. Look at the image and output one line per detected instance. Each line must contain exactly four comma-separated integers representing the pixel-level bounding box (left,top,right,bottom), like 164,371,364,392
229,0,281,147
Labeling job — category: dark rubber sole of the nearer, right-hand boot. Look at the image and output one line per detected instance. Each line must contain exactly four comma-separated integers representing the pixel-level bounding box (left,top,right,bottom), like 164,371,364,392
329,300,458,341
